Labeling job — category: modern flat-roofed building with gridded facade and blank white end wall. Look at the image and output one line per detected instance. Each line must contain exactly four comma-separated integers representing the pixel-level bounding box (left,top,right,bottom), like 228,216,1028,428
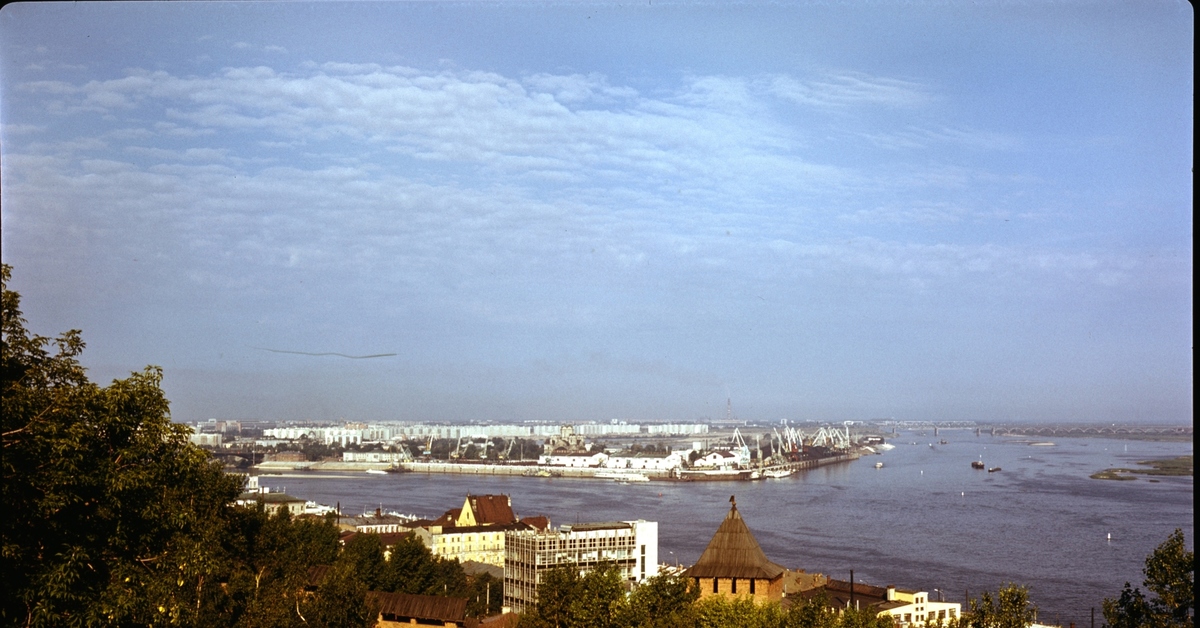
504,520,659,612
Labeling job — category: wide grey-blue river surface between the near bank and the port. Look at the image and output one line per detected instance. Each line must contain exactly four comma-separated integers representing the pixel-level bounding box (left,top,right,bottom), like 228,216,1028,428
260,430,1195,628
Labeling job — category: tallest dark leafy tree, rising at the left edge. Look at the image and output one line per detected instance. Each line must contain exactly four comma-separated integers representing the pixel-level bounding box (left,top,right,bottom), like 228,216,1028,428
0,264,240,626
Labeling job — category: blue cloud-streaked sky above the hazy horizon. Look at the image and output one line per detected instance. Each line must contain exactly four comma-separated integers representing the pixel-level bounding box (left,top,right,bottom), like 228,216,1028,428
0,0,1194,424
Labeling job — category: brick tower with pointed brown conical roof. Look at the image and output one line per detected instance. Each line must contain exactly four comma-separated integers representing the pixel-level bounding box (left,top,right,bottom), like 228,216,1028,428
684,497,787,602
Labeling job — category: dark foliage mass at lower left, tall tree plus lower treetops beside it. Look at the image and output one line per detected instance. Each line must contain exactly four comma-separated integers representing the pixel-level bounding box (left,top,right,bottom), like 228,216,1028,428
0,264,368,627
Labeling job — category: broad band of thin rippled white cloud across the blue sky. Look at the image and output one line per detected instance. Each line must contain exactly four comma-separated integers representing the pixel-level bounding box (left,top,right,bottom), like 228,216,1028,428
6,64,1156,319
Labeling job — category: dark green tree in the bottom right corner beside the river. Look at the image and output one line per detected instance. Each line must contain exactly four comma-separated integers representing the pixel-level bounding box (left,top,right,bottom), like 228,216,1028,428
1102,528,1195,628
